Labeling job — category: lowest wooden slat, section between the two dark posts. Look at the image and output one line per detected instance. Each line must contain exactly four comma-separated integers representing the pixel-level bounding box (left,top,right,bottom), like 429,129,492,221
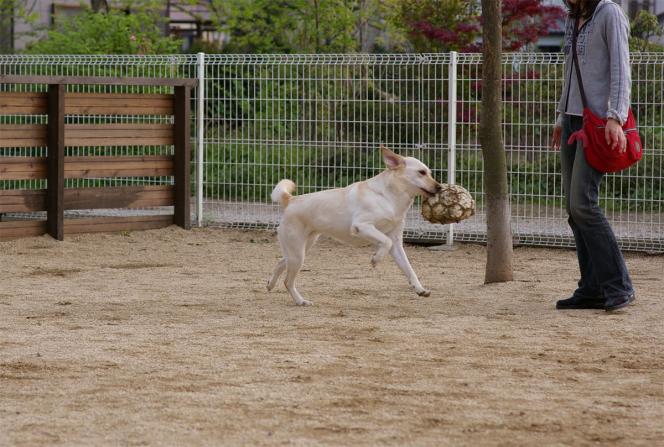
65,215,173,234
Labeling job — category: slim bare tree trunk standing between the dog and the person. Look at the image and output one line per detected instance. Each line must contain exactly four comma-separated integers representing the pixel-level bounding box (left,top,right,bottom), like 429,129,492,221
480,0,513,283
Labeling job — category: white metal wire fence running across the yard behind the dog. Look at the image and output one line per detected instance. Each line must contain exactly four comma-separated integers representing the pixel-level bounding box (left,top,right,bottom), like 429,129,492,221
0,53,664,252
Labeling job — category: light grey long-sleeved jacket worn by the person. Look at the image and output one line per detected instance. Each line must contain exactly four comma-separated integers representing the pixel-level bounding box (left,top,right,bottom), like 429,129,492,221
557,0,632,124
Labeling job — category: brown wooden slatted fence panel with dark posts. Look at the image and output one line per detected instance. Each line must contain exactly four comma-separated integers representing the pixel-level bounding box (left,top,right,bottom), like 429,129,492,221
0,75,195,240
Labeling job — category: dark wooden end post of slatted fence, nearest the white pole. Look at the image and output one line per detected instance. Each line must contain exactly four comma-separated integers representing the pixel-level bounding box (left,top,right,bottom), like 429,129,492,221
173,85,191,230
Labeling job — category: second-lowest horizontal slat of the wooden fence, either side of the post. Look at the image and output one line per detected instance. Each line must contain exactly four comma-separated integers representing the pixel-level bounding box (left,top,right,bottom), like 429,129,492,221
0,186,175,213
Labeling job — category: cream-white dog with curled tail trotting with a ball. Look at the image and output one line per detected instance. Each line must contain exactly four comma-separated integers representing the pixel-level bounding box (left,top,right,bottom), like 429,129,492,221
267,146,441,306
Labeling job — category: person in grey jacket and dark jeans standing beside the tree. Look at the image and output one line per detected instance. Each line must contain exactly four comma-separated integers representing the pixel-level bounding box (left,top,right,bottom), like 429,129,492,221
551,0,635,311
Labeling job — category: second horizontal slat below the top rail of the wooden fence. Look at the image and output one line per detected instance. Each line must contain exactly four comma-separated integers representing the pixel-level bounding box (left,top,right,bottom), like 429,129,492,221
0,123,173,147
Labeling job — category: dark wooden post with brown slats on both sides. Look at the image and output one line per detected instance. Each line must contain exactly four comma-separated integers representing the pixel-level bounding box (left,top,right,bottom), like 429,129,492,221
46,84,65,241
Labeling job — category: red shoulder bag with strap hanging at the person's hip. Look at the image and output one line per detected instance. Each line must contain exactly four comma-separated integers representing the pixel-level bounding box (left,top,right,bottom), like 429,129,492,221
567,19,643,172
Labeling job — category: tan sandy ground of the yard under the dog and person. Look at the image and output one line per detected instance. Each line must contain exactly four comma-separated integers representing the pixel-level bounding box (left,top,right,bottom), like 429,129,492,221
0,228,664,446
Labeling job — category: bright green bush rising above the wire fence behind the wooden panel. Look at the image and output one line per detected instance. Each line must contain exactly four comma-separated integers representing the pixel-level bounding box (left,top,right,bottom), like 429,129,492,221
26,10,180,54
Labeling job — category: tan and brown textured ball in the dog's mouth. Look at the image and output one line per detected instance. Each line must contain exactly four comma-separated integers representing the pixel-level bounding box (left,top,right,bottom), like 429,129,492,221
422,183,475,224
